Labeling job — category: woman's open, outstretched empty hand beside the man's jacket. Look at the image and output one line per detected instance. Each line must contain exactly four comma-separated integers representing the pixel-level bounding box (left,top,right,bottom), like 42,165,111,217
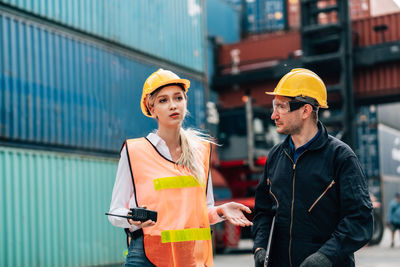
217,202,253,227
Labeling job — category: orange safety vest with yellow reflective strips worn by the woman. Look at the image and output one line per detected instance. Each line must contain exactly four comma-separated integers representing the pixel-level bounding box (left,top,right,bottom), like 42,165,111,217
126,138,213,267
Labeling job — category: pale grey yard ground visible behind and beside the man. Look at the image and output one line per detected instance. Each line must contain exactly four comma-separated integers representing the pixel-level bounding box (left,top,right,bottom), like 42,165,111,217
214,229,400,267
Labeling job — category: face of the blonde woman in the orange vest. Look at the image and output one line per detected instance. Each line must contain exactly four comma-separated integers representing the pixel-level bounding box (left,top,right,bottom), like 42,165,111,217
149,85,187,127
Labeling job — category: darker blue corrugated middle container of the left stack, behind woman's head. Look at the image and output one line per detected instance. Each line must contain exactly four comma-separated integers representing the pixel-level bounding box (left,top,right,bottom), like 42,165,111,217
0,13,205,152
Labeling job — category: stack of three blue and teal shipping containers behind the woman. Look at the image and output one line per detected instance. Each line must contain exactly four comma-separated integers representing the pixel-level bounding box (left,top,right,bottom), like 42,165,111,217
0,0,205,266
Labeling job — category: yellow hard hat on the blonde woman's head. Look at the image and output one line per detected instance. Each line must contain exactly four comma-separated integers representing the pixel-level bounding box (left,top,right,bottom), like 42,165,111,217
140,69,190,117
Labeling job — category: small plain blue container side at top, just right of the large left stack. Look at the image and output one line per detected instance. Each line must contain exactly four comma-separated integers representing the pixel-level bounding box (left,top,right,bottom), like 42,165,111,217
206,0,240,44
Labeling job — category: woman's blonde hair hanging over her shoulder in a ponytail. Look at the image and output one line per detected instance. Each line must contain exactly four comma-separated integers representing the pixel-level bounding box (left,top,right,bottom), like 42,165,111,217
146,88,215,185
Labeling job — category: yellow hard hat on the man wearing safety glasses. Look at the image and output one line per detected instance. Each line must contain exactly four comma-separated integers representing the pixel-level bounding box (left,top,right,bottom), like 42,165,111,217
266,68,328,108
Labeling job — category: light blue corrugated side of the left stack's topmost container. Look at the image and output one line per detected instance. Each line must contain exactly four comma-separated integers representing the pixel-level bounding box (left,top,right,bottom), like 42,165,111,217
1,0,205,71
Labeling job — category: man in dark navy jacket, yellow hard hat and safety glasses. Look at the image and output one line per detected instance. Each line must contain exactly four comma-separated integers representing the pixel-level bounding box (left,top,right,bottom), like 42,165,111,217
253,69,373,267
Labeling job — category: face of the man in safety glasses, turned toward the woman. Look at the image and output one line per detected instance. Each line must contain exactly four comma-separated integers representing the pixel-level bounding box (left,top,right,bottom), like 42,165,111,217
271,95,303,135
